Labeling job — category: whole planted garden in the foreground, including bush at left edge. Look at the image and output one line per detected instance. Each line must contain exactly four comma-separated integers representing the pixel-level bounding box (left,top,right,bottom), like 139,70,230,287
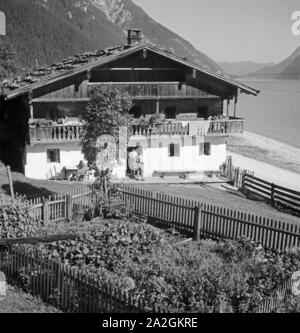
0,192,300,313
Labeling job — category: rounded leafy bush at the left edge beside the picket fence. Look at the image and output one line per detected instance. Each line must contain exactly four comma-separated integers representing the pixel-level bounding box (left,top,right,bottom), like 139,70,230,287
0,197,40,239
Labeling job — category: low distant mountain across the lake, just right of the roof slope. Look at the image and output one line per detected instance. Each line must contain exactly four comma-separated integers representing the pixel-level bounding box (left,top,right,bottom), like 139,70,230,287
218,61,273,77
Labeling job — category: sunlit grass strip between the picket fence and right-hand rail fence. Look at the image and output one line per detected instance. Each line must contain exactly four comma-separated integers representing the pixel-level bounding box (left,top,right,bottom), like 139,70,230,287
135,184,300,224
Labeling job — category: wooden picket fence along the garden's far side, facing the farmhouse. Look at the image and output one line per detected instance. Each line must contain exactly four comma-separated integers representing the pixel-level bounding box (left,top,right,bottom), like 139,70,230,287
4,182,300,251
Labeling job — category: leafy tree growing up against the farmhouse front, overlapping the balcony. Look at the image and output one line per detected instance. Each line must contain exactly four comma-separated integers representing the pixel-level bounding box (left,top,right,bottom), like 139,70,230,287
81,87,133,164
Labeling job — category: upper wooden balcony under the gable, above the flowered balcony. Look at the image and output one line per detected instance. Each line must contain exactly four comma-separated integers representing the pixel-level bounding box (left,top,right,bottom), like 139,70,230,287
89,82,218,99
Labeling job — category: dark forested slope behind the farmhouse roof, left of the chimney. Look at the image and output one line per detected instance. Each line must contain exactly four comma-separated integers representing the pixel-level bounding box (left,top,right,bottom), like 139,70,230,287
0,0,124,67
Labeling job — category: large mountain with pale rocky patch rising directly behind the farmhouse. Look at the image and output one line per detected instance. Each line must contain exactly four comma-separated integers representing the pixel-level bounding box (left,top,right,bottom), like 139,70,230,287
0,0,220,71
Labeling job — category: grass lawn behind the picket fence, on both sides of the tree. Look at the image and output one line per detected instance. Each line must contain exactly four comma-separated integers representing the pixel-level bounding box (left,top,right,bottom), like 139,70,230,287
0,165,300,224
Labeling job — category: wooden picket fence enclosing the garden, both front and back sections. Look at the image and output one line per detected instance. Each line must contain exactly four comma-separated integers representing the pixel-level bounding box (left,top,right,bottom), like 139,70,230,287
0,184,300,313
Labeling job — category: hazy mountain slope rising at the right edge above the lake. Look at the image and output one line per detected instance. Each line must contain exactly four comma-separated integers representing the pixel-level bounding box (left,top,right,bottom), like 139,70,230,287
246,47,300,79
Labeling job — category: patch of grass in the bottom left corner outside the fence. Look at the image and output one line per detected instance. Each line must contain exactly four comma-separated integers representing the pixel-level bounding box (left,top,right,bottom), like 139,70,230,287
0,286,60,313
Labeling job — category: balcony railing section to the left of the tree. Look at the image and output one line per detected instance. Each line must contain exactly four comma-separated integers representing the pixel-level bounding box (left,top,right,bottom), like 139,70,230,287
29,125,82,144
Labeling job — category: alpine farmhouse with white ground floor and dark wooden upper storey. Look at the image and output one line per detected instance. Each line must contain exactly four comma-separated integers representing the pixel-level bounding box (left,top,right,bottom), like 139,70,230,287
0,29,259,179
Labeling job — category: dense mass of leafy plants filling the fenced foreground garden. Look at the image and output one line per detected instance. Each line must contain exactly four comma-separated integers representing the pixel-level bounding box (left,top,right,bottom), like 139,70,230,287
25,220,300,313
